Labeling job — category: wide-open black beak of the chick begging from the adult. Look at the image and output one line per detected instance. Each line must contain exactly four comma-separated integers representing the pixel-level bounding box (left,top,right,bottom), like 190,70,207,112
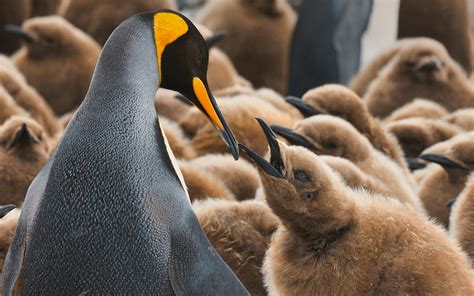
239,117,286,179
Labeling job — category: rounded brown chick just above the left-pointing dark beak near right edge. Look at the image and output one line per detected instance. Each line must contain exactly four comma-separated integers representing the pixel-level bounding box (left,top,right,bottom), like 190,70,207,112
384,118,463,157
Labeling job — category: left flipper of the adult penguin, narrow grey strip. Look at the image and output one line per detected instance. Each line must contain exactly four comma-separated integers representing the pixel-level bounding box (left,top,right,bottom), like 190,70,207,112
0,160,54,295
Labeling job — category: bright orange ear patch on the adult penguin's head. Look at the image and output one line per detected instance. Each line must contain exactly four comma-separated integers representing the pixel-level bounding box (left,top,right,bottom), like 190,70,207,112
153,12,189,77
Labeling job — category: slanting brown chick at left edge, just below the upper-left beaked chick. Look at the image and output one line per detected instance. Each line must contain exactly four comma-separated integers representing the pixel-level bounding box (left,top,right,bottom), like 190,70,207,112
0,57,63,136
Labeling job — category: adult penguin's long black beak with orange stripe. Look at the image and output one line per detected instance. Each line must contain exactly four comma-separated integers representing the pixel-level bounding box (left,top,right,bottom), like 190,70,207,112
190,77,239,160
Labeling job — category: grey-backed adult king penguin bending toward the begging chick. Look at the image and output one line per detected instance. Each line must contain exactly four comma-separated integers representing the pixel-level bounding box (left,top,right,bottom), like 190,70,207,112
2,10,247,295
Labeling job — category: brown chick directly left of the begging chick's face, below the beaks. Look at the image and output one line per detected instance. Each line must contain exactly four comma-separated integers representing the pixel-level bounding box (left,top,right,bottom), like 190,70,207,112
189,154,260,201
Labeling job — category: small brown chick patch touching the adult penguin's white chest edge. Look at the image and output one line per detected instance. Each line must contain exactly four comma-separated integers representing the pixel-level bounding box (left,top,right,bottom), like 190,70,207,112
179,161,235,201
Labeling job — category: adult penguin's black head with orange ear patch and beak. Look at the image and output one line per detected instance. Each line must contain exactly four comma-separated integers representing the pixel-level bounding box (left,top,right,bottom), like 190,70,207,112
153,10,239,159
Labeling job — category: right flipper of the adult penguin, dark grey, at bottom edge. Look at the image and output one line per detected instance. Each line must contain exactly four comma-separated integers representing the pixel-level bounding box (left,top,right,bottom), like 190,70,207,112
169,209,250,296
